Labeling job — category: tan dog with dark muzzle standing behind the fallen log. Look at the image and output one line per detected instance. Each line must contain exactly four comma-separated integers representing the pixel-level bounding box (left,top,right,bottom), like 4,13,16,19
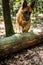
16,0,35,33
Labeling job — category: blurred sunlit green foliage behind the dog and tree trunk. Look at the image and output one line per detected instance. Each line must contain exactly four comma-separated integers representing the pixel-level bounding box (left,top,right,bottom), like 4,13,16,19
0,0,43,20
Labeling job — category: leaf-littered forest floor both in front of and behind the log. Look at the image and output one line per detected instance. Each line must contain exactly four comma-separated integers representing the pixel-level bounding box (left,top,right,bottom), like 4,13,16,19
0,17,43,65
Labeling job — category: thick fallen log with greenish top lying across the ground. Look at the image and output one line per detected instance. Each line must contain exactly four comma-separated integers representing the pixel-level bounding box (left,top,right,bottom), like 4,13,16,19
0,32,43,57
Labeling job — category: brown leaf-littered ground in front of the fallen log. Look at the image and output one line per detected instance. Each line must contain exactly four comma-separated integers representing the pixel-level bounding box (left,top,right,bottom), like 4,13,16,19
0,43,43,65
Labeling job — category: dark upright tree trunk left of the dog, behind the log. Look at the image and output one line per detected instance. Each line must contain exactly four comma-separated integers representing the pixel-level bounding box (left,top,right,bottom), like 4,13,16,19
2,0,14,37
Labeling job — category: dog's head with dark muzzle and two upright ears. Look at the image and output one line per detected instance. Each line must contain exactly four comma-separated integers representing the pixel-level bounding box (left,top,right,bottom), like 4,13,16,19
22,0,35,21
